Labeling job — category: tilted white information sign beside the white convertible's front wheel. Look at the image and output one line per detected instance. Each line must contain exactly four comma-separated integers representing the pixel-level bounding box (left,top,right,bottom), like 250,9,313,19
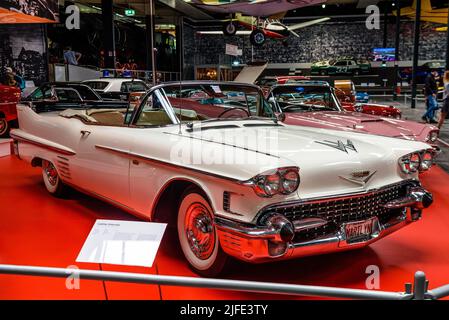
76,220,167,267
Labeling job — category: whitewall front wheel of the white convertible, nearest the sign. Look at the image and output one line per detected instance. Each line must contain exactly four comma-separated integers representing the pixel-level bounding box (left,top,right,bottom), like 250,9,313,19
177,187,229,277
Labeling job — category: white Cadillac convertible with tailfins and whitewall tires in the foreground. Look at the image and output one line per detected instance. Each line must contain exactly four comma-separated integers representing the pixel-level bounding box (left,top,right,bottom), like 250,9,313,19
11,82,433,276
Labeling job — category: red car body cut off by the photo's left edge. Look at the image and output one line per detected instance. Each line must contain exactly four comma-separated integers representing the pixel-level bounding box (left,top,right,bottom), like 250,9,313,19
0,84,20,137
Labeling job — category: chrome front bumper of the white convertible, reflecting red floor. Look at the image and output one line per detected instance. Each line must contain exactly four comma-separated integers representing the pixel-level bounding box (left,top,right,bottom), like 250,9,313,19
215,185,433,263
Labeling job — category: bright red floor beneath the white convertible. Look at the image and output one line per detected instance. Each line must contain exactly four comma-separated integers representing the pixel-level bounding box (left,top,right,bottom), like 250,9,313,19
0,157,449,299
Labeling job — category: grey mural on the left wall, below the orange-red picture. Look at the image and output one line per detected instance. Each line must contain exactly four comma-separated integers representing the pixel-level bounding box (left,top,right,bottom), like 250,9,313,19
0,25,47,85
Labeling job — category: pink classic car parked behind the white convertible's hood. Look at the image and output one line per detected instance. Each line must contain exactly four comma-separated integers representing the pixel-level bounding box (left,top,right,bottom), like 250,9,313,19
268,83,439,150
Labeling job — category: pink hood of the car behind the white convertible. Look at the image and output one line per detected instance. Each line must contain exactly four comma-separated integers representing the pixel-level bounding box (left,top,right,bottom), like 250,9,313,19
285,111,425,140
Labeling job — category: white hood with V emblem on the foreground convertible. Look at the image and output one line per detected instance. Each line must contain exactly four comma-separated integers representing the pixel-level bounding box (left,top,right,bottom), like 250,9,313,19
162,121,429,197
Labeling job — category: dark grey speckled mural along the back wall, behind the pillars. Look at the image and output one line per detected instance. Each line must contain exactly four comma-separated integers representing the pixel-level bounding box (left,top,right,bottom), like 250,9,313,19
184,22,446,64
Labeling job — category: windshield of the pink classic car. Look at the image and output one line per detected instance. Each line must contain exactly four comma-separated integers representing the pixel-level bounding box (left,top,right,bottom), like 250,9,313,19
270,86,341,112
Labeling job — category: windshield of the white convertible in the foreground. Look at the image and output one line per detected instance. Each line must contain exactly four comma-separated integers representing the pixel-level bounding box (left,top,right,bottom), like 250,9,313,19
134,83,274,126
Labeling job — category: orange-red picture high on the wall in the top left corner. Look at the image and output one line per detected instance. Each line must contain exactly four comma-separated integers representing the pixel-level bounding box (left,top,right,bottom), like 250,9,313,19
0,0,59,23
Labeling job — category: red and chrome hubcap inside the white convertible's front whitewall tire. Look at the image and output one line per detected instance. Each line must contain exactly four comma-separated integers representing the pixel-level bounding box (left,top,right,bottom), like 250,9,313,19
185,203,215,260
